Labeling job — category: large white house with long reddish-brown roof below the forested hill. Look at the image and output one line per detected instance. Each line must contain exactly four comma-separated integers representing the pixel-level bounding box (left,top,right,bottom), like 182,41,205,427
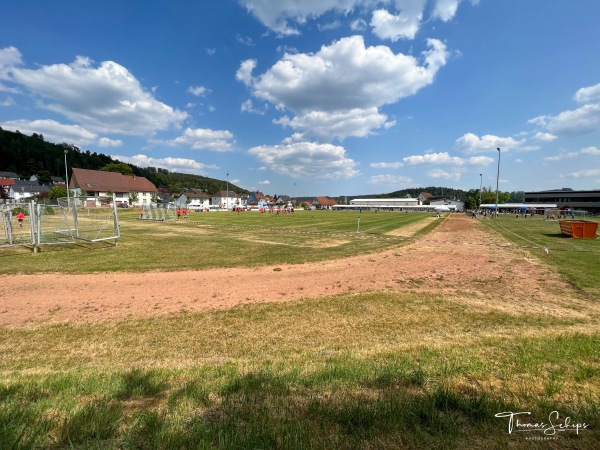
69,168,158,206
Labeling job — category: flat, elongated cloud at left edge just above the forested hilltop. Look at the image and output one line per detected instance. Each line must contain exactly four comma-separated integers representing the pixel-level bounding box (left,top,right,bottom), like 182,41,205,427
0,119,123,147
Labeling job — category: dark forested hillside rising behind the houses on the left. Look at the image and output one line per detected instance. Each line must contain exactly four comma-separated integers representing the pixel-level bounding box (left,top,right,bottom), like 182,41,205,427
0,128,249,194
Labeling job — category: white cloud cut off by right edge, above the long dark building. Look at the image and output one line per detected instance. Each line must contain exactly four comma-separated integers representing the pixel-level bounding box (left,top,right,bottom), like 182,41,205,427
528,84,600,136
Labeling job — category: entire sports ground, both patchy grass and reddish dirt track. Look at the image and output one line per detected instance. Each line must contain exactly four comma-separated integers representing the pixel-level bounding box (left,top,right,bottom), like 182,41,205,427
0,211,600,449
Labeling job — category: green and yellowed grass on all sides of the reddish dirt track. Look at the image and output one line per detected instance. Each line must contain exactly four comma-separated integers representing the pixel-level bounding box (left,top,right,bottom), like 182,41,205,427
0,211,600,449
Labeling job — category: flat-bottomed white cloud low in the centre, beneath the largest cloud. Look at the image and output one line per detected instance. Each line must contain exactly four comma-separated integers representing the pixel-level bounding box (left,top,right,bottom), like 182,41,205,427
248,142,358,180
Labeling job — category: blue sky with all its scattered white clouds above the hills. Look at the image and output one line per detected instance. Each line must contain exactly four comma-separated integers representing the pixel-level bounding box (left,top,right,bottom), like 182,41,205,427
0,0,600,196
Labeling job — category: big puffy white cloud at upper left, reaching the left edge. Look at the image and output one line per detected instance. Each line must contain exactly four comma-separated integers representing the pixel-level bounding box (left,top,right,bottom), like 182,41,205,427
0,48,188,135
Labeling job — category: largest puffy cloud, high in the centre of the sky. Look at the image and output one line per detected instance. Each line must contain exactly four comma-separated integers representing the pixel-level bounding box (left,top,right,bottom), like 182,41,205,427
236,36,448,139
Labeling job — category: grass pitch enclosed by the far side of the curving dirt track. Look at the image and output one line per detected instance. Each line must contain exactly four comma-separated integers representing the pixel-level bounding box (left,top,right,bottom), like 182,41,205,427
0,211,435,274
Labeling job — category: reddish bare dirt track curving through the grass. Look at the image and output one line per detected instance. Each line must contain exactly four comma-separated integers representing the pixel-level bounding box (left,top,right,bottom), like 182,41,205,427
0,214,590,327
